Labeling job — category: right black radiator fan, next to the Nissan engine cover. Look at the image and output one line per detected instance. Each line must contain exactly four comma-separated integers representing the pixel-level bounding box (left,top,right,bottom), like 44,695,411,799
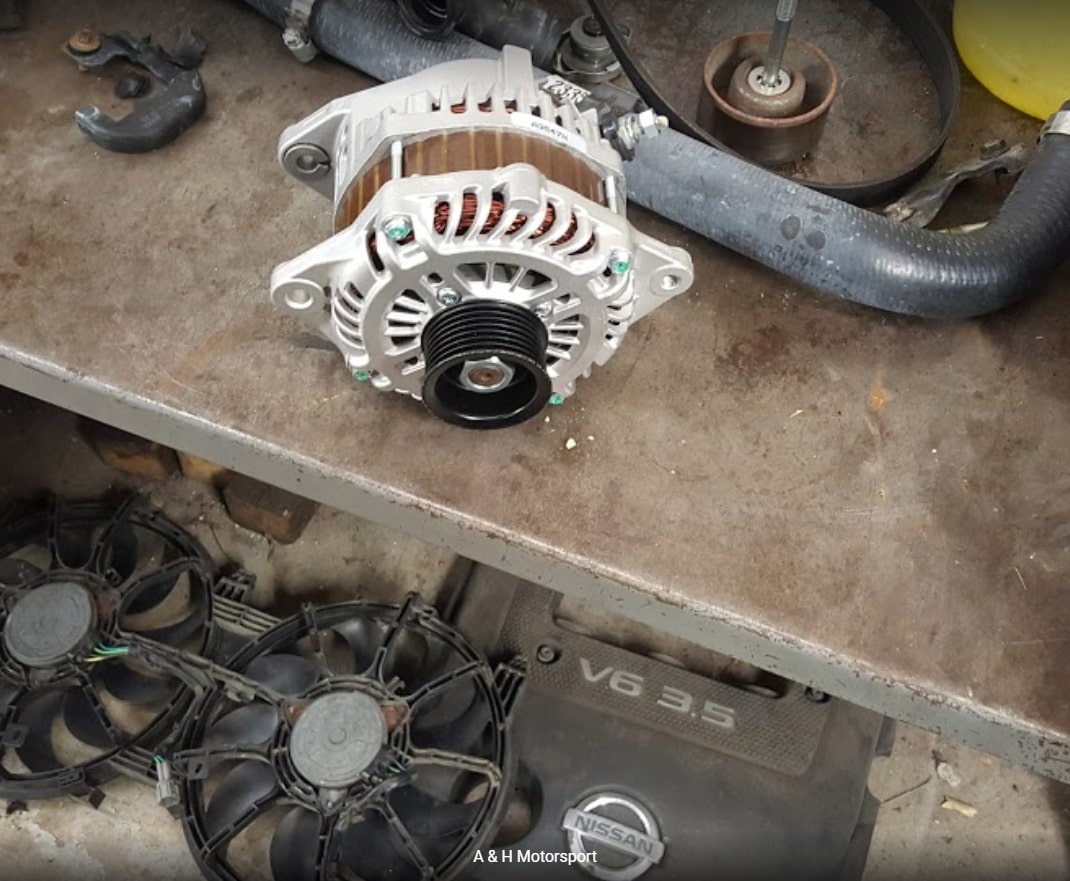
173,597,523,881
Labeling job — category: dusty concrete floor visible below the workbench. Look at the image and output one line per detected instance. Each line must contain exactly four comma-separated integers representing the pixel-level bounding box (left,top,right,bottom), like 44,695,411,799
0,390,1070,881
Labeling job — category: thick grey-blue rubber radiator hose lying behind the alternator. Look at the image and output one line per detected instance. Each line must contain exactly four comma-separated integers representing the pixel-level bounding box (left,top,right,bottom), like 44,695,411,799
247,0,1070,319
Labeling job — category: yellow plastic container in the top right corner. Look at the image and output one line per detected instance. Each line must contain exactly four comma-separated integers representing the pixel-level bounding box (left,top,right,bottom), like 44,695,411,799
954,0,1070,119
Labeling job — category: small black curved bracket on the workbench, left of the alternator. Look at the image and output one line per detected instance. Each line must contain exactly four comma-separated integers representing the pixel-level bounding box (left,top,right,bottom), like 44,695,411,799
64,31,207,153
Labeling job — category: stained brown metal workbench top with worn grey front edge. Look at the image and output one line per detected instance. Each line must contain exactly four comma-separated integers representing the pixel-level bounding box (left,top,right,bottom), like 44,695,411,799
0,3,1070,780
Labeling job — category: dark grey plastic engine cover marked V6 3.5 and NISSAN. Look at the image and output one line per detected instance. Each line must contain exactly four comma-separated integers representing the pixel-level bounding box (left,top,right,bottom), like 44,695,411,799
454,567,892,881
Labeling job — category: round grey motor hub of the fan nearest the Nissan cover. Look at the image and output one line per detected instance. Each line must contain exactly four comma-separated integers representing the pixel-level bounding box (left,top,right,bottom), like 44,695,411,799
290,692,386,789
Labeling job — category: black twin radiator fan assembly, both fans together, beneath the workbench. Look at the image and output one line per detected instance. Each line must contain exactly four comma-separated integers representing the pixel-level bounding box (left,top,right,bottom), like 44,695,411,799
0,499,524,881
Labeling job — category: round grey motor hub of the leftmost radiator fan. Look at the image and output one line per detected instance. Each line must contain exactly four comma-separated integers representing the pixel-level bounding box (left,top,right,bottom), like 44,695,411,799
3,581,95,667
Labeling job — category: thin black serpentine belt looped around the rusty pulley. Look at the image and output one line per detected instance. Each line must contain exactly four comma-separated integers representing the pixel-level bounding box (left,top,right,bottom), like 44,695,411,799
590,0,962,206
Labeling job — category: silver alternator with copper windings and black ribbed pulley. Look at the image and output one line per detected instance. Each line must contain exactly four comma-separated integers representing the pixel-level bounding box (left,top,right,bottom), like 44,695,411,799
271,47,692,428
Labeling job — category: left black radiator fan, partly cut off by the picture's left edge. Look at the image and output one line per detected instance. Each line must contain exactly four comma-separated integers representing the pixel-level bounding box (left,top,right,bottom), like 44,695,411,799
0,498,214,799
